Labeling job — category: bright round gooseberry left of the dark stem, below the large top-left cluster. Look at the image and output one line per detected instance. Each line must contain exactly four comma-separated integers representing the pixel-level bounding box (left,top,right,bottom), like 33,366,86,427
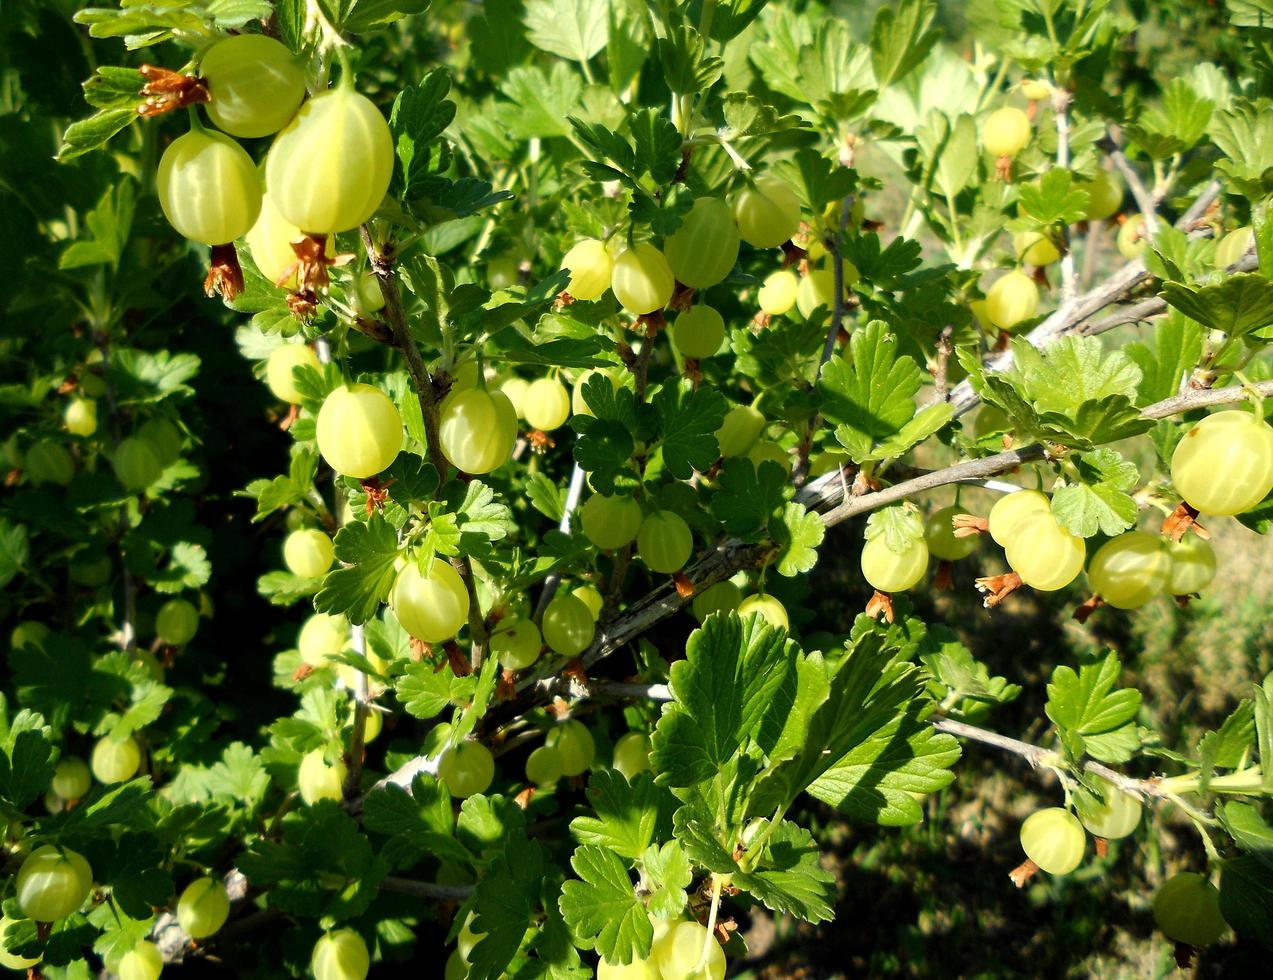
317,384,402,480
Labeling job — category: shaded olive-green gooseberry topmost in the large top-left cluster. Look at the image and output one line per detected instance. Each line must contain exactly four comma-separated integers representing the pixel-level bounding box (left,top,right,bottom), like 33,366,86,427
199,34,306,139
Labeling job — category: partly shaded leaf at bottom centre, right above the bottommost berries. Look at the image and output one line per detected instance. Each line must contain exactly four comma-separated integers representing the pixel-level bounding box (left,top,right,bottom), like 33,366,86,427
732,820,835,923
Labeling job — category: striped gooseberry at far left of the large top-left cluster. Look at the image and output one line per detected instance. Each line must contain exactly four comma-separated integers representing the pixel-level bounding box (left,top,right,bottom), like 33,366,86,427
155,126,261,246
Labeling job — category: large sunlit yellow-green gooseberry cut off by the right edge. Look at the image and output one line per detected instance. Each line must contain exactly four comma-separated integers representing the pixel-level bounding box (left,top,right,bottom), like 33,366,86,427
1171,409,1273,517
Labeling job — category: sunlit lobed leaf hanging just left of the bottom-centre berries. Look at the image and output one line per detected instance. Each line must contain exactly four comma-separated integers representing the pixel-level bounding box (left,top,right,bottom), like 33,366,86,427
559,844,654,963
